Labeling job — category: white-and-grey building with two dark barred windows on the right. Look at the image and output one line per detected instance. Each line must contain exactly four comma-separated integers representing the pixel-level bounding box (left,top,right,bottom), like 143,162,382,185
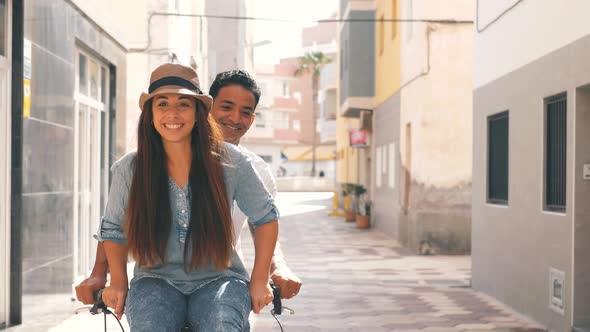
472,0,590,331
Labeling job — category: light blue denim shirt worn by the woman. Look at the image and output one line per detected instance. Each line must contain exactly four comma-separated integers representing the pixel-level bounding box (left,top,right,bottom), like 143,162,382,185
98,143,279,294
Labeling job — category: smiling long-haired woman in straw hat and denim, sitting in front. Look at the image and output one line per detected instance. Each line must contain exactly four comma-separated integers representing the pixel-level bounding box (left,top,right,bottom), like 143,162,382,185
99,64,278,331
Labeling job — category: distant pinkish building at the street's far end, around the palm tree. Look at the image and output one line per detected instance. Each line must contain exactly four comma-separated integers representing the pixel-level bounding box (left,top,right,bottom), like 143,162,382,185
242,19,336,180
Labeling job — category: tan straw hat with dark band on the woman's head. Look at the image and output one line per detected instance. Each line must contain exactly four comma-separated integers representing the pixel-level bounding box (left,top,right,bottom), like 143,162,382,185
139,63,213,111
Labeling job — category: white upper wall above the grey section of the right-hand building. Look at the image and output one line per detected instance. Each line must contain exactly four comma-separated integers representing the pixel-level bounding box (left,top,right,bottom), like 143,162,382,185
474,0,590,88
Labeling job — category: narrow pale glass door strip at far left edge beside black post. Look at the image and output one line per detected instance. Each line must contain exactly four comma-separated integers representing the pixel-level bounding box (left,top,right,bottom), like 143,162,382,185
0,0,12,329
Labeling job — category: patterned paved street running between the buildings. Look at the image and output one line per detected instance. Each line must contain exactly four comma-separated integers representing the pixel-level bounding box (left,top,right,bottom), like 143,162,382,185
8,193,542,332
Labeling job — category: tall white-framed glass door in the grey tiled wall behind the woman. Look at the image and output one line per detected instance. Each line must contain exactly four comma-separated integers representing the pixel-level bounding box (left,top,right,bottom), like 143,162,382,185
73,51,109,284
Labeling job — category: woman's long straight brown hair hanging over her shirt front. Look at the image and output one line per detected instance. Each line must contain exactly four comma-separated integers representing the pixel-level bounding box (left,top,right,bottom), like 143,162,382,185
125,100,234,270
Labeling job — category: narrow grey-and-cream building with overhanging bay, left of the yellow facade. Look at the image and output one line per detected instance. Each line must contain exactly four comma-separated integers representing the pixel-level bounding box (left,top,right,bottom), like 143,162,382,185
336,0,375,188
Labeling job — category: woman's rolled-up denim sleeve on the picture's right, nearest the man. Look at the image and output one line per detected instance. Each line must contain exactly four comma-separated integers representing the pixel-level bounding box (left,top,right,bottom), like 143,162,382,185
234,152,279,227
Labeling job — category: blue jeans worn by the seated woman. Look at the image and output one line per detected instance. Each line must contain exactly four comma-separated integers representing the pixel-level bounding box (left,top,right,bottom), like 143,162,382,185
125,277,251,332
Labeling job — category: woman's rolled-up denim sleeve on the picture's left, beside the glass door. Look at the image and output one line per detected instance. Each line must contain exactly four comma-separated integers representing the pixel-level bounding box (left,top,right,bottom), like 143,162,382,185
98,158,130,244
